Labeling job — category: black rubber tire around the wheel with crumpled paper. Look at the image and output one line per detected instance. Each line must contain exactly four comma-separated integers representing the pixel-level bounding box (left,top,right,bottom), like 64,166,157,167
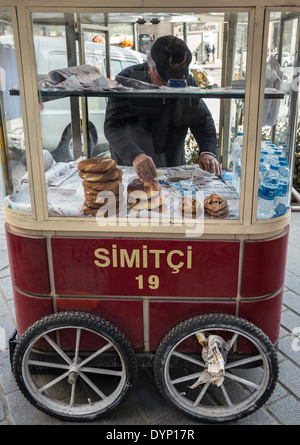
154,314,279,424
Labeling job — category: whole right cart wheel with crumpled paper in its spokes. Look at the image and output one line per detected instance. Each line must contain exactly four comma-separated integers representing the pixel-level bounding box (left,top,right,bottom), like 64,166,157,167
154,314,279,423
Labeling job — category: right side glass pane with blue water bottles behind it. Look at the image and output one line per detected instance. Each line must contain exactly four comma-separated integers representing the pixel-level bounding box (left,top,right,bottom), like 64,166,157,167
257,12,300,219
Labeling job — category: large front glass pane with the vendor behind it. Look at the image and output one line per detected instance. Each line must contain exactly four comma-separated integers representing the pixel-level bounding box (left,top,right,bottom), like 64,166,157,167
32,13,248,224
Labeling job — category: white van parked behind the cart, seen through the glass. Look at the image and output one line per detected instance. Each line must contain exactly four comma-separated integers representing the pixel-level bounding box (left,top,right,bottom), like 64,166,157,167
3,36,146,161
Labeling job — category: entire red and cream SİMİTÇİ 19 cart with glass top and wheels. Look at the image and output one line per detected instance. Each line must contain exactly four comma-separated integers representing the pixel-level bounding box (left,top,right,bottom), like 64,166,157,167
0,0,300,423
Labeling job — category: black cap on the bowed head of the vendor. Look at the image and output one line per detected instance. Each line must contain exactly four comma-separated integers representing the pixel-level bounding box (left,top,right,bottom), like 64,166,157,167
151,35,192,81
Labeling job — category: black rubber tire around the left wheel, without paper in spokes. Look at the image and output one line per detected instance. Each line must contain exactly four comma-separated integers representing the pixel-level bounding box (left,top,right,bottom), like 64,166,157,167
13,311,137,422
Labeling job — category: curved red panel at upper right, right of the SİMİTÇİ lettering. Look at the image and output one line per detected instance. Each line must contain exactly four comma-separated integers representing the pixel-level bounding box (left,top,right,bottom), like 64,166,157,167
242,230,288,298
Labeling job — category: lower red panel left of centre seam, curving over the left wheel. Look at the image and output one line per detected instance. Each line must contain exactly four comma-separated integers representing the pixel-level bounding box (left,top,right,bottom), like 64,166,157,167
56,298,144,349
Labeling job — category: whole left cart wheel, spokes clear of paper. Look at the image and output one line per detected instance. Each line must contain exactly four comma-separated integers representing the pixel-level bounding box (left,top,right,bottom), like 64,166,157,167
13,312,137,421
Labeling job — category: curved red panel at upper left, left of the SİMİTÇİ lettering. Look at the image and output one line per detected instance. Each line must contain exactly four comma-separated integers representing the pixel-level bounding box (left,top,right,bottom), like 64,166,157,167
5,224,50,294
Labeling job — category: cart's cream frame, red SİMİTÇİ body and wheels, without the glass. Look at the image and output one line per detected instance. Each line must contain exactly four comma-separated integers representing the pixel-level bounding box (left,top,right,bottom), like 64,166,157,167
0,0,300,423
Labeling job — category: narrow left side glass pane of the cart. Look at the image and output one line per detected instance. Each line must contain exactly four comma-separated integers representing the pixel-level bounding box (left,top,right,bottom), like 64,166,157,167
0,12,31,213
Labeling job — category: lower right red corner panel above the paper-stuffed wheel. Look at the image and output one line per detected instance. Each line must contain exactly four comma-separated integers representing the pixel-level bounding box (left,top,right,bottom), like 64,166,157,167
240,291,283,346
